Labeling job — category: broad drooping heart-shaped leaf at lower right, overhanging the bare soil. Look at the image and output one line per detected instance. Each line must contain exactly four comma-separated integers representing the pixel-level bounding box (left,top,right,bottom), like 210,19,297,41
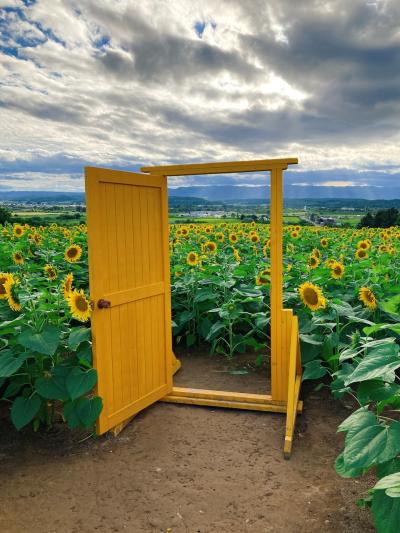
343,425,387,468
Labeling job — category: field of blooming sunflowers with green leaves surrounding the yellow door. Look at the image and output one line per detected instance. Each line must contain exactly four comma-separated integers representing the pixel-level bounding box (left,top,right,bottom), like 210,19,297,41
0,219,400,533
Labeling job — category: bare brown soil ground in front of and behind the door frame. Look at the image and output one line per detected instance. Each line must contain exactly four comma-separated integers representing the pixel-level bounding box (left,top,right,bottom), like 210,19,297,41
0,356,374,533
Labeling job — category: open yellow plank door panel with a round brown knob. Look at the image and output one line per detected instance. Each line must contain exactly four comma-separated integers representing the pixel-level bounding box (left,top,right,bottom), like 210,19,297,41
85,167,172,434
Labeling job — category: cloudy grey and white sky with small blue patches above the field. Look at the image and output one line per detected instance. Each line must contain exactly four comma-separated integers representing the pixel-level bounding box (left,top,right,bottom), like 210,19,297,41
0,0,400,196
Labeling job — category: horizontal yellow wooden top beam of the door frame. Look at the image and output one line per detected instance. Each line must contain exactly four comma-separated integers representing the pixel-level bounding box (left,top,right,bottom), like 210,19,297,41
140,157,298,176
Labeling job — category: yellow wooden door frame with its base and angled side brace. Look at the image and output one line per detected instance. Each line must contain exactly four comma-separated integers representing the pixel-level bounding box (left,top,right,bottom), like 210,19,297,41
141,158,303,458
